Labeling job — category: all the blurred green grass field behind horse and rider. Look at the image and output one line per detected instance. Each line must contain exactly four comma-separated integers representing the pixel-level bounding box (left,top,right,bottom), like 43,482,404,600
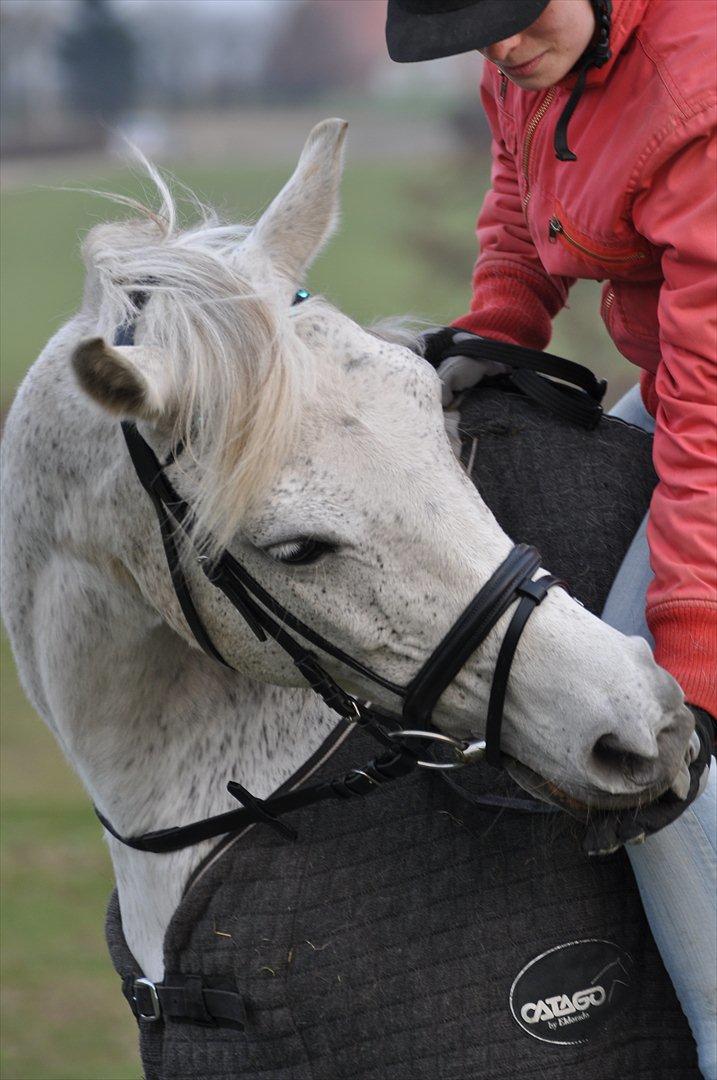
0,156,634,1080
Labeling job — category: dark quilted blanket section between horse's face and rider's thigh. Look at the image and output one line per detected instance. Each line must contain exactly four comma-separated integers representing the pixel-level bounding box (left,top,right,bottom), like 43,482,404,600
459,387,658,615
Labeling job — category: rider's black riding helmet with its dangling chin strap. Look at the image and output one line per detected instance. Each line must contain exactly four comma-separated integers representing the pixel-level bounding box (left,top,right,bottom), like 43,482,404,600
385,0,612,161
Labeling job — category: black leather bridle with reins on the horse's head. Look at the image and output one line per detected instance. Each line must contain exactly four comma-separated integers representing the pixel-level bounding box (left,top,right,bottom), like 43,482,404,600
97,291,564,852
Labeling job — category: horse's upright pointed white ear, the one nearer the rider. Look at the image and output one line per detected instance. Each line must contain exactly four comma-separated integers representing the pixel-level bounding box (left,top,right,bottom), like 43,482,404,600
252,120,348,284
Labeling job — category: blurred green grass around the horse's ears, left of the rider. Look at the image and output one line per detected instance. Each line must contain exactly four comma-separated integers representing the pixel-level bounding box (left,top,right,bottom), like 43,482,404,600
1,160,481,406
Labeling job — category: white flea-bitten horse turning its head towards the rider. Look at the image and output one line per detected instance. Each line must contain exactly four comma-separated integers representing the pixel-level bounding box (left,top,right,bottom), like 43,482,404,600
2,120,692,981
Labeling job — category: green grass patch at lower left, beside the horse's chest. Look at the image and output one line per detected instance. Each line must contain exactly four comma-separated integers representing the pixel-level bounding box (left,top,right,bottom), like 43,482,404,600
0,639,140,1080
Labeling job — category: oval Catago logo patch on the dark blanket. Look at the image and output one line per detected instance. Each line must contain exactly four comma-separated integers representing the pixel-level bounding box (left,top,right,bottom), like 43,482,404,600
510,937,634,1047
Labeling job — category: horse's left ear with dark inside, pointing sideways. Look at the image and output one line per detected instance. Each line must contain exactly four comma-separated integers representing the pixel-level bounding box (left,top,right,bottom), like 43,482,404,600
72,337,172,423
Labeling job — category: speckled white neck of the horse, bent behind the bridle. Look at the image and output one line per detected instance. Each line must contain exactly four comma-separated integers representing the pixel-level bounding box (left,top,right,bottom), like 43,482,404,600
3,343,336,978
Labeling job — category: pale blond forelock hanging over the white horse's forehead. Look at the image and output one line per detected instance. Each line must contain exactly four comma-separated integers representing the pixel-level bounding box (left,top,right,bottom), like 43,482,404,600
77,168,319,551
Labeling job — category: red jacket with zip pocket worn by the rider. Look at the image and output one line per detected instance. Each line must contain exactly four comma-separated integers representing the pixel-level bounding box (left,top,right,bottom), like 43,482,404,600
456,0,717,716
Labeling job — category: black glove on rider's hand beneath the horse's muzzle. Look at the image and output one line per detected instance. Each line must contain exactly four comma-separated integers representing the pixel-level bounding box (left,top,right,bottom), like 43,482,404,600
582,705,715,855
